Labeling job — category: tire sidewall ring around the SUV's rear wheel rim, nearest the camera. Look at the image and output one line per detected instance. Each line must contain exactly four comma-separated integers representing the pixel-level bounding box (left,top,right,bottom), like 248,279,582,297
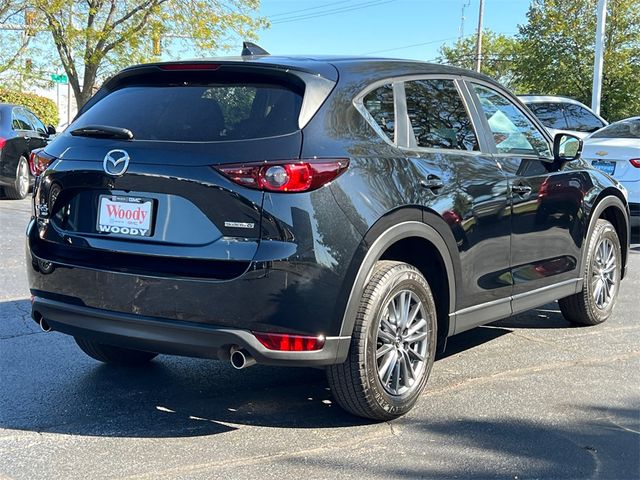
364,264,437,416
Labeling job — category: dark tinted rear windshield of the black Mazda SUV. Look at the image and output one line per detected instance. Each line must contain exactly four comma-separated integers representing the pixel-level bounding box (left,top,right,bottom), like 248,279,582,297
71,83,302,142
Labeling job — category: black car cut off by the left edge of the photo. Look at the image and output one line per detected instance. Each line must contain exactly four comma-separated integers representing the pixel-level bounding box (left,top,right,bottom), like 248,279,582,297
0,103,56,200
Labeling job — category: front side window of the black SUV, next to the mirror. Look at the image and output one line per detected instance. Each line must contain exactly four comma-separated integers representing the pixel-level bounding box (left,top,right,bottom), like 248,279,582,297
473,84,551,158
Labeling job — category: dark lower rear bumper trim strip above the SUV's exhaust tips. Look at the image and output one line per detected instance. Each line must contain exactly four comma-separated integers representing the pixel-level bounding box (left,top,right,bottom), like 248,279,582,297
32,297,350,367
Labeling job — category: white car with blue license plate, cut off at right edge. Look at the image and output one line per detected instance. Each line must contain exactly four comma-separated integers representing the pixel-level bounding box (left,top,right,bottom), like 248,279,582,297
582,116,640,227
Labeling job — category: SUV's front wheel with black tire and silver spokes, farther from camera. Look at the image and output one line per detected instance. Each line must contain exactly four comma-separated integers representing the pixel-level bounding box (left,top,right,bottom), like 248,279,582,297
558,219,622,325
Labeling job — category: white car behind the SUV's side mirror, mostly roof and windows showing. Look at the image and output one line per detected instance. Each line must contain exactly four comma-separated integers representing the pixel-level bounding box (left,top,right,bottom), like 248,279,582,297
518,95,609,138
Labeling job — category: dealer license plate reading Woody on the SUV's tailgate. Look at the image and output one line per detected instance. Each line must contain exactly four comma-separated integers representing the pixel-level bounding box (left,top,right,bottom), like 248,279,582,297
97,195,153,237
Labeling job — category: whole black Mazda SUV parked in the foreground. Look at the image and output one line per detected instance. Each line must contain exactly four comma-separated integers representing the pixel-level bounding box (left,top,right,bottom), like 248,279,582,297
27,51,629,419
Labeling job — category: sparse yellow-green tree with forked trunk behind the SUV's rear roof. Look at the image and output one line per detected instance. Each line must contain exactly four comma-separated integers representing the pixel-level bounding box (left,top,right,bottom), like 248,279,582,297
27,0,267,106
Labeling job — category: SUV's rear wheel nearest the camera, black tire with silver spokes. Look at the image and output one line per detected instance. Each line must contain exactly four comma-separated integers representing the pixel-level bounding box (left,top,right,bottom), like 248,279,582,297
327,261,437,420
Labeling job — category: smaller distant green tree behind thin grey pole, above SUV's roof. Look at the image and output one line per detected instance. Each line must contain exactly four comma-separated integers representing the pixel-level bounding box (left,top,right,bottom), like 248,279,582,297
438,30,518,89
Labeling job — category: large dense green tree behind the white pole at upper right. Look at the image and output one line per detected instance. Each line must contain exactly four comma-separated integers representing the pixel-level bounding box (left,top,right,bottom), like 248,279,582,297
516,0,640,121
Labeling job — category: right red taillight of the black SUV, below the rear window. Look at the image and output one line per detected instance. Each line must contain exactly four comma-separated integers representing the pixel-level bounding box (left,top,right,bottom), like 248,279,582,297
216,158,349,192
